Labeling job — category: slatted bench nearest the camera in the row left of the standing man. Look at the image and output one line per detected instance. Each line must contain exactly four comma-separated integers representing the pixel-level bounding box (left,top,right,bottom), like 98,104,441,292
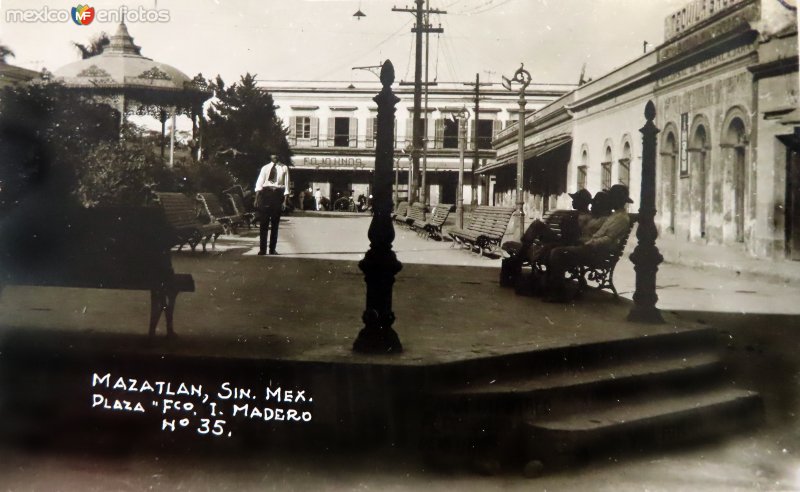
155,192,224,251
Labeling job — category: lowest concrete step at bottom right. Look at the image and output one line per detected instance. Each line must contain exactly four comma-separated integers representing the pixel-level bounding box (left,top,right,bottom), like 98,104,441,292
523,387,763,466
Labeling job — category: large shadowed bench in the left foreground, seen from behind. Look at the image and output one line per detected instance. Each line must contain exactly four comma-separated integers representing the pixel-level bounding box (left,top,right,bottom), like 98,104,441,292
0,206,195,336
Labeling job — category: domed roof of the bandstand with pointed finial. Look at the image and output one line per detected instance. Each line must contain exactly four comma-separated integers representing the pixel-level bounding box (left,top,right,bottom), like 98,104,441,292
54,22,199,92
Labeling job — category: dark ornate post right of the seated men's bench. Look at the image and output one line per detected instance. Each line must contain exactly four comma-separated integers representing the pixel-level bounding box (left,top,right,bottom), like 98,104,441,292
628,101,664,323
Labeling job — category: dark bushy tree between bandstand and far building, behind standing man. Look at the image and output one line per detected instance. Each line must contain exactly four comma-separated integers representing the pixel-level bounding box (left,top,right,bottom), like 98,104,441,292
203,73,291,183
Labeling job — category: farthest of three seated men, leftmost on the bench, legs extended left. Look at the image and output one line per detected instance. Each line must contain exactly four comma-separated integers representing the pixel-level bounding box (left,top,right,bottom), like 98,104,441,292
500,188,592,285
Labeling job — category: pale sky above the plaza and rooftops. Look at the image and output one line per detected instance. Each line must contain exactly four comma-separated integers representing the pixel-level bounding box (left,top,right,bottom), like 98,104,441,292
0,0,688,84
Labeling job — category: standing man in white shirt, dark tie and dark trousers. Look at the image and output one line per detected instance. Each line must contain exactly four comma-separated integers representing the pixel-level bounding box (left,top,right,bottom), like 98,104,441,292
255,155,289,255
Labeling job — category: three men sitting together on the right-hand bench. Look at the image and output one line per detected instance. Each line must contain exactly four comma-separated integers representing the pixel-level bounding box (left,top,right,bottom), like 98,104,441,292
502,184,633,302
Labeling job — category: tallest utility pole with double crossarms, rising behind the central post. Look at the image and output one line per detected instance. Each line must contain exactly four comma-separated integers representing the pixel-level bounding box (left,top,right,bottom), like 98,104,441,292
392,0,447,203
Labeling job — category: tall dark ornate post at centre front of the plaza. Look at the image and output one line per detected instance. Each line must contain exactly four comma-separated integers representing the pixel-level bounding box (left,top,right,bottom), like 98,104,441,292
353,60,403,354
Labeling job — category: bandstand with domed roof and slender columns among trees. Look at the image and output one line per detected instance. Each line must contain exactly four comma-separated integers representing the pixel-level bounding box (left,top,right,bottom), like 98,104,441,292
53,22,213,167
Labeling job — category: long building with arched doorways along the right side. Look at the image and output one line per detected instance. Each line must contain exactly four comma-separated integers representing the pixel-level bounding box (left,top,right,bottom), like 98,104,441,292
490,0,800,259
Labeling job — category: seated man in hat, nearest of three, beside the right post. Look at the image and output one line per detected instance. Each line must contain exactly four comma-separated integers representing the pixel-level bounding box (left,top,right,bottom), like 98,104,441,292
547,184,633,302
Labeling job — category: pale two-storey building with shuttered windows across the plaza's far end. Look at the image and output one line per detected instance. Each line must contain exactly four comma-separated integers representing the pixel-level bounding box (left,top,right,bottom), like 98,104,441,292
261,81,572,205
